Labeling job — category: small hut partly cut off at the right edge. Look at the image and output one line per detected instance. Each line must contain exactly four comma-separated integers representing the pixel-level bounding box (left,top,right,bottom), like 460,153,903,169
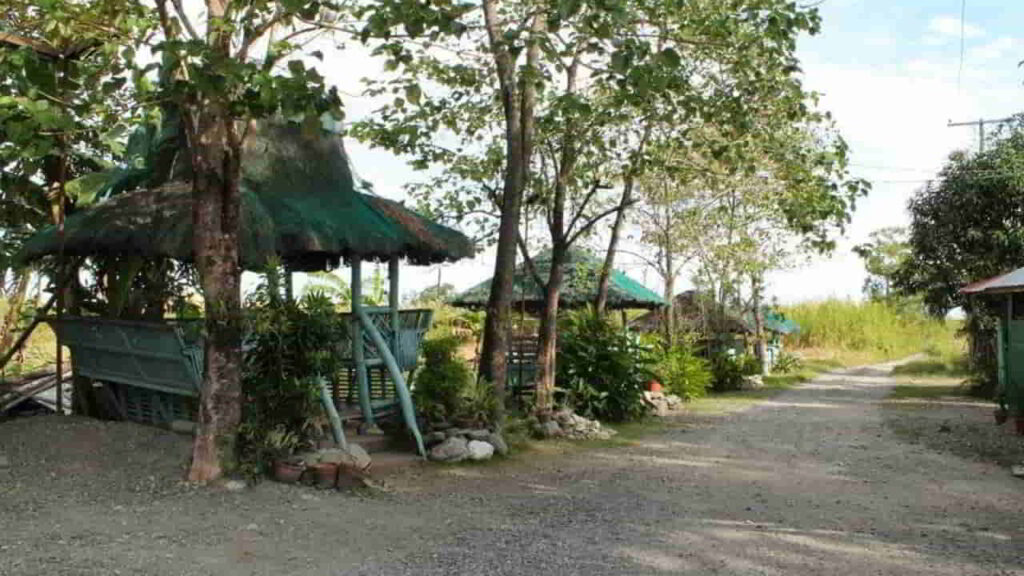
961,268,1024,434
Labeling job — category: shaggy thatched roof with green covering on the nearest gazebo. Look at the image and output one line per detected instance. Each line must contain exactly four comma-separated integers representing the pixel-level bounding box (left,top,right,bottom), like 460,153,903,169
19,123,473,271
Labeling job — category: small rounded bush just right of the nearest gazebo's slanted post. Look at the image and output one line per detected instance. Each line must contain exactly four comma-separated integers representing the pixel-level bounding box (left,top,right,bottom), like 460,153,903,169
413,335,473,422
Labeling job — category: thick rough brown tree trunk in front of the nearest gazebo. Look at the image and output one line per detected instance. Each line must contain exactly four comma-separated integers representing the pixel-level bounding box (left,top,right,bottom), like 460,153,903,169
188,102,242,483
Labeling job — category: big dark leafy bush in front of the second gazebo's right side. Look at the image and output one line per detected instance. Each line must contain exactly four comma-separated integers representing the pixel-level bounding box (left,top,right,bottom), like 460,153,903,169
556,310,656,422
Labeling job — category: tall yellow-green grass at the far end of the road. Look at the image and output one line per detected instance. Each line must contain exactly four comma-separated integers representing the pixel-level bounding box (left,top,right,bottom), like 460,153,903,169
782,299,963,364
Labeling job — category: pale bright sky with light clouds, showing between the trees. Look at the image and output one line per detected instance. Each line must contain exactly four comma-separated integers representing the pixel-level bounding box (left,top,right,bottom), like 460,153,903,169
288,0,1024,303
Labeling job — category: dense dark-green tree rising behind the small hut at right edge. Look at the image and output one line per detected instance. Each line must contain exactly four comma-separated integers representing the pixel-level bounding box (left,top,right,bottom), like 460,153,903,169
894,118,1024,318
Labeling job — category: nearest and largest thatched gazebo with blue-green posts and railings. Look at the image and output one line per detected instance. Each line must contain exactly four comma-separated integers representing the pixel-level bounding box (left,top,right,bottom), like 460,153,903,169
20,118,473,455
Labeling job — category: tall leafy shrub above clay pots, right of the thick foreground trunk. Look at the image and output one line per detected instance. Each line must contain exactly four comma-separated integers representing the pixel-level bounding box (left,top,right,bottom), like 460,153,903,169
239,271,345,476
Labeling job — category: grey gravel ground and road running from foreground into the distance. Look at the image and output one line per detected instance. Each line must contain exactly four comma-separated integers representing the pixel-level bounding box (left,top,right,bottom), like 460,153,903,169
0,366,1024,576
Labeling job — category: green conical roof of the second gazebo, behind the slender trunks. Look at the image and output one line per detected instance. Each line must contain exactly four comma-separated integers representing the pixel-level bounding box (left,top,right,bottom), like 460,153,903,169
452,248,665,311
